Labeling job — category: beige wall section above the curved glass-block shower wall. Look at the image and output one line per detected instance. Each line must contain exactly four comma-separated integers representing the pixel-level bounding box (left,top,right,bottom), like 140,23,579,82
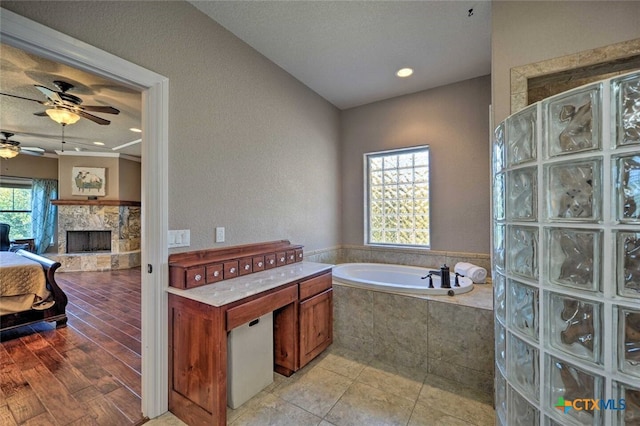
491,1,640,123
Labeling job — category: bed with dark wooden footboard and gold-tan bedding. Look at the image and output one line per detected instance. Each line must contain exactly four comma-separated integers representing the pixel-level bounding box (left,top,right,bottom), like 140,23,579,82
0,250,67,331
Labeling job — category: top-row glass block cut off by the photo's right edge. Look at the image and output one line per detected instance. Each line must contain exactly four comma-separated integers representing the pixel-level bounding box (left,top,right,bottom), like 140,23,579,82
611,73,640,146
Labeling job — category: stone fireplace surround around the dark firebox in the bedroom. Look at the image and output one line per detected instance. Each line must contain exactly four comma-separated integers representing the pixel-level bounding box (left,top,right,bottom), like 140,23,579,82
47,201,141,272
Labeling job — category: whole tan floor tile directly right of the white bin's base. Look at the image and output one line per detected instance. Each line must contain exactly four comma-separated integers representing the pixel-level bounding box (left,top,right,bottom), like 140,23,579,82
273,366,352,417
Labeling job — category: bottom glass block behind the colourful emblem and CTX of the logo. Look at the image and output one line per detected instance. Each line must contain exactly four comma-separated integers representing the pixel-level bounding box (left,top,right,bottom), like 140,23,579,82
546,356,604,425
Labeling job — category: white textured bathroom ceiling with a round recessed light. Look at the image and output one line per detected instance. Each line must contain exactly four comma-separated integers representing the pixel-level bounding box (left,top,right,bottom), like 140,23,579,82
190,0,491,109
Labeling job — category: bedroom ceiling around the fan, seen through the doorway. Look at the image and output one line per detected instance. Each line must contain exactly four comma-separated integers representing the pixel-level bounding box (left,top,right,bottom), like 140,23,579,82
0,44,142,156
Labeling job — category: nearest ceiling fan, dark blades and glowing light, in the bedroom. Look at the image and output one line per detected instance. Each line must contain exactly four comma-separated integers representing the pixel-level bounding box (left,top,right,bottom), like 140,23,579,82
0,80,120,126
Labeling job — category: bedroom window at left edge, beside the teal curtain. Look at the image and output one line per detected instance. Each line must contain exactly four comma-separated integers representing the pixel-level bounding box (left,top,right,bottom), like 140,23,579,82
0,178,32,240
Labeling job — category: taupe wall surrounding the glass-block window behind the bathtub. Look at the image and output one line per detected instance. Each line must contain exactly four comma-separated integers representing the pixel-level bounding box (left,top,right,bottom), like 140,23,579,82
341,76,491,253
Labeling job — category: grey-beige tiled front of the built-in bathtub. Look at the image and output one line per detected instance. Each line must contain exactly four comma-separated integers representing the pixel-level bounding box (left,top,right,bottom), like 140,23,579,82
333,281,494,394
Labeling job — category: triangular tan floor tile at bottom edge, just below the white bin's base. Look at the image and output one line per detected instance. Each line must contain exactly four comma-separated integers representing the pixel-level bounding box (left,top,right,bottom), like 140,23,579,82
230,394,322,426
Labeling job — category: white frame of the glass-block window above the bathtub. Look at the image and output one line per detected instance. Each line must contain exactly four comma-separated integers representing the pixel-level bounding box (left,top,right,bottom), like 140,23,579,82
362,144,432,250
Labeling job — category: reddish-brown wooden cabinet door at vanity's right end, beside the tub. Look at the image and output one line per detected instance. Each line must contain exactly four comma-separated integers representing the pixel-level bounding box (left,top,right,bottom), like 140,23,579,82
300,288,333,368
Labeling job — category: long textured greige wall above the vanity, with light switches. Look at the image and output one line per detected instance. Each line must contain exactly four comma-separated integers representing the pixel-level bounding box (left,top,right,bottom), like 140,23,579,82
2,1,340,250
